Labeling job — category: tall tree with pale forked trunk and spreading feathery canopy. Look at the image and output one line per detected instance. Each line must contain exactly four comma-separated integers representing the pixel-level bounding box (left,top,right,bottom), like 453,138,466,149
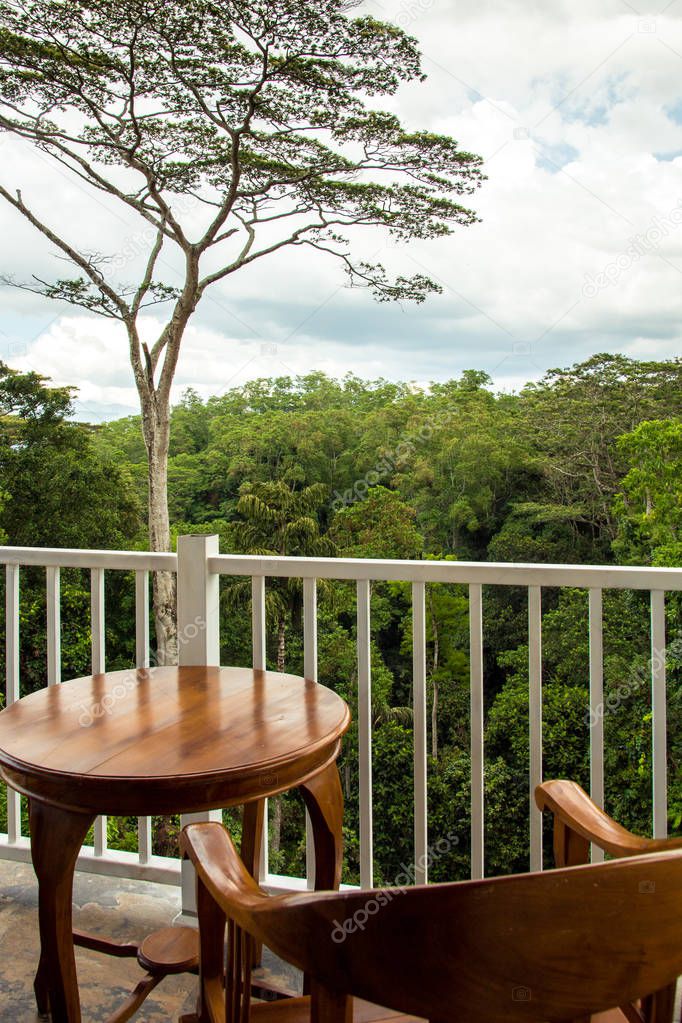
0,0,482,660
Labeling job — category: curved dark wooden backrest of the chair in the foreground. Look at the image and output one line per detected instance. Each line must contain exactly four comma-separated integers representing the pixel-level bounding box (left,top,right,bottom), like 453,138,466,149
230,852,682,1023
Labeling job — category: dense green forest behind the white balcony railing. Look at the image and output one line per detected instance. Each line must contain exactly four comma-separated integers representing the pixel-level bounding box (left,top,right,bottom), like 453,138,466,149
0,355,682,884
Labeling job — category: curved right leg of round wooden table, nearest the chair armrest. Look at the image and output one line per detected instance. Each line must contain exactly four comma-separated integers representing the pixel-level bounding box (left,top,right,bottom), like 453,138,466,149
301,763,344,891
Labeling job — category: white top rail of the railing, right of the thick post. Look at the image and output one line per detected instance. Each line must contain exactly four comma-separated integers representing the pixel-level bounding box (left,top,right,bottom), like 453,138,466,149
209,554,682,590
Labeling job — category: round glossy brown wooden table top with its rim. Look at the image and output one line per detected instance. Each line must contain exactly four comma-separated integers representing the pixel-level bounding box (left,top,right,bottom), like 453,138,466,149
0,666,350,814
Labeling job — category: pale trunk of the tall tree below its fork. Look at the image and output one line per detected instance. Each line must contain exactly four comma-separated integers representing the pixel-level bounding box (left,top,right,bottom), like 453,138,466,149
142,394,178,664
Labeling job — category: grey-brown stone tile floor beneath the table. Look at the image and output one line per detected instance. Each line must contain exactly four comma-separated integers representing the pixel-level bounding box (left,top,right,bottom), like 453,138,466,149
0,860,295,1023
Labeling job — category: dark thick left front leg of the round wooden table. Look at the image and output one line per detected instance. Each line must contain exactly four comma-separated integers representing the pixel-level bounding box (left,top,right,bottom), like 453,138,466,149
30,799,94,1023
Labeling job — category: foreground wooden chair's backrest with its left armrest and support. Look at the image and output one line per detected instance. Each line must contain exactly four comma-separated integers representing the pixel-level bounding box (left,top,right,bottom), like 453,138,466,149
182,824,682,1023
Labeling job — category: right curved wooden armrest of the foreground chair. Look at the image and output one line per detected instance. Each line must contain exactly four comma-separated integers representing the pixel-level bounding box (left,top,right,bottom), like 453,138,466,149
535,779,682,865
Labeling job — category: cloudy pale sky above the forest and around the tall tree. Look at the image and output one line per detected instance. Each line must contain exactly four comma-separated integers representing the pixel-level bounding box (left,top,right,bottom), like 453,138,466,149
0,0,682,420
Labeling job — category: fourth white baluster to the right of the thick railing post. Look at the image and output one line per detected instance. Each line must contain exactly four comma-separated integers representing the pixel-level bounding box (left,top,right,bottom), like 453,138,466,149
412,582,428,885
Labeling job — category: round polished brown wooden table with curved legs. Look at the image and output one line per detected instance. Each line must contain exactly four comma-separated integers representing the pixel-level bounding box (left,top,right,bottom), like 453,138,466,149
0,667,350,1023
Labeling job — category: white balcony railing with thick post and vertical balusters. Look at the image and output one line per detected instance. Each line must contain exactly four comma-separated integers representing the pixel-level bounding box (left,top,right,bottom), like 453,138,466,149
0,536,682,912
